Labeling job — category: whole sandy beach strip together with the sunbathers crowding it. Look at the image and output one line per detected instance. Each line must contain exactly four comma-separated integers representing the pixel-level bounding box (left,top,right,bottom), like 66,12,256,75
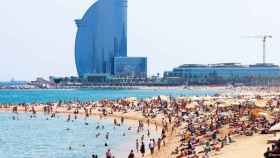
0,87,280,158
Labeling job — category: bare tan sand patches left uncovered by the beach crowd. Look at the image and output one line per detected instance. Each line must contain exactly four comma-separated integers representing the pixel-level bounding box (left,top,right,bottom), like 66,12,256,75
3,86,278,158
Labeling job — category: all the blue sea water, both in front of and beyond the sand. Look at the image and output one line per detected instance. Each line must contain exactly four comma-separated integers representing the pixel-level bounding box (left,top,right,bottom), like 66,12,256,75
0,89,216,158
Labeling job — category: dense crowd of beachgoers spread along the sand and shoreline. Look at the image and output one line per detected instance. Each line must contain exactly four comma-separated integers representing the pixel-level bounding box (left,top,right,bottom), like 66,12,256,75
0,89,280,158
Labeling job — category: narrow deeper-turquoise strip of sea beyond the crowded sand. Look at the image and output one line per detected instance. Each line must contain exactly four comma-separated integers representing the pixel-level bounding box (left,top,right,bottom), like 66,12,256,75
0,89,216,103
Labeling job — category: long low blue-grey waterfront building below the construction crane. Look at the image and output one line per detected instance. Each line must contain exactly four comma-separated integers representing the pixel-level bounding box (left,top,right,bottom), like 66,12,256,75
164,63,280,84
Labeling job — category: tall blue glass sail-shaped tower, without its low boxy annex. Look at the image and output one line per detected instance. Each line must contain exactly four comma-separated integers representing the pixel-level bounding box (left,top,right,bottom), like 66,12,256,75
75,0,127,77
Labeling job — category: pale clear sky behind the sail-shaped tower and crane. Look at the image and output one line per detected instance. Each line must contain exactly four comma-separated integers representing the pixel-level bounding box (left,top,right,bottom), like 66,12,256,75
0,0,280,81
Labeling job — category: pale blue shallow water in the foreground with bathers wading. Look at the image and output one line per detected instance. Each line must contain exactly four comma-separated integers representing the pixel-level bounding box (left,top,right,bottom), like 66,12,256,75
0,112,159,158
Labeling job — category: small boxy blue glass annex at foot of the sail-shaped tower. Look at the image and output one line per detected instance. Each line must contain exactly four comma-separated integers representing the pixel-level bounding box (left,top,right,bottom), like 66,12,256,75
114,57,147,78
